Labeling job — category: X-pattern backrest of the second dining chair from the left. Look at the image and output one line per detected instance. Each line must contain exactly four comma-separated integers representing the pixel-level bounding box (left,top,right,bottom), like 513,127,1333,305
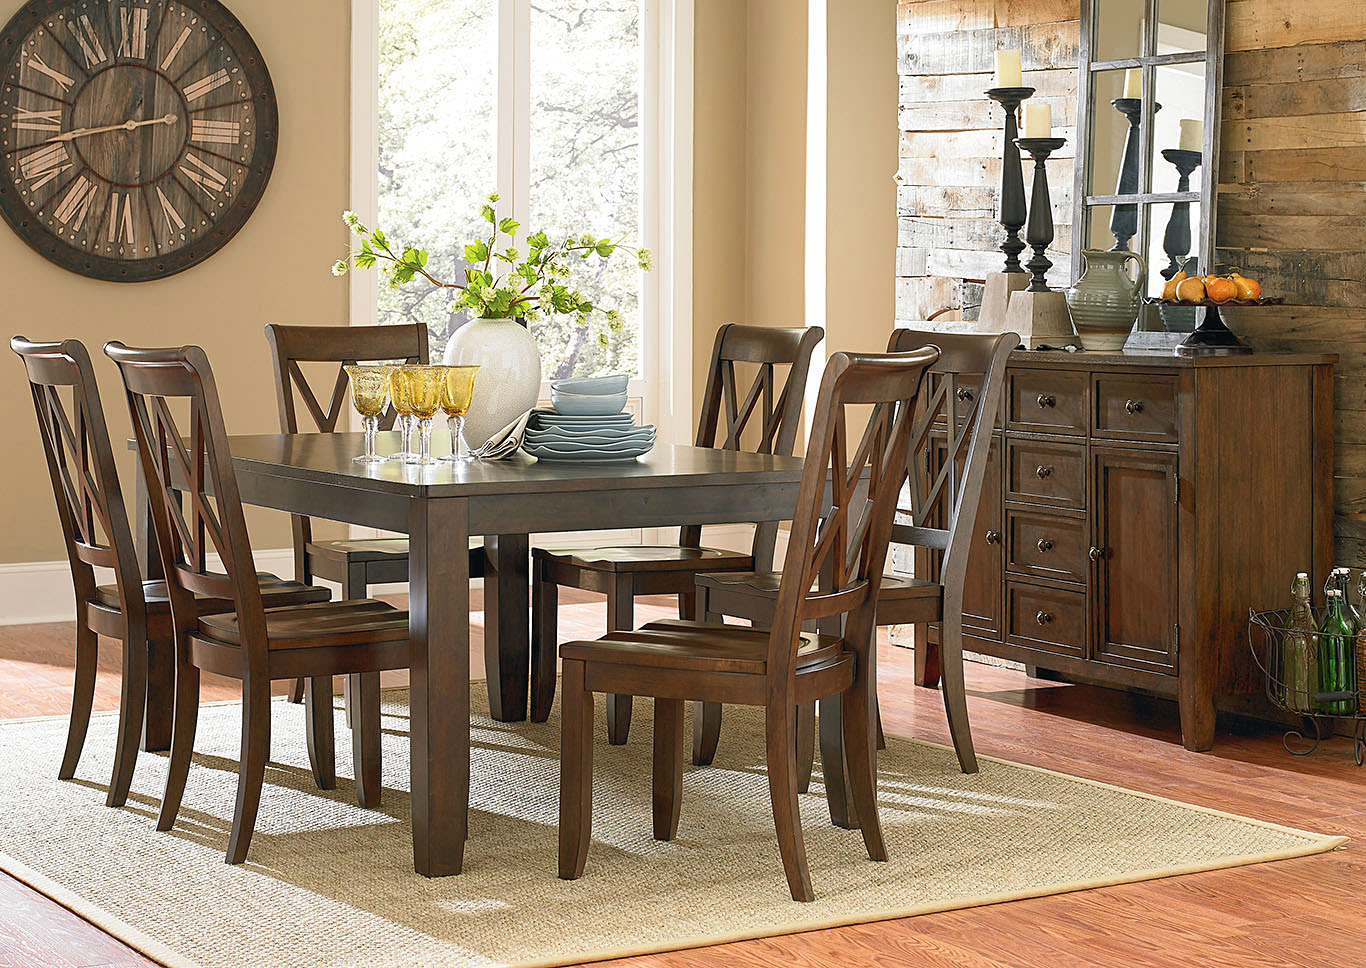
104,341,265,664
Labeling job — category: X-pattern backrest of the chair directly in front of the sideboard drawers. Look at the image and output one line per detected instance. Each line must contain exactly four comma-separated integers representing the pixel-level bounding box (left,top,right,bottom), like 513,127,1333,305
888,329,1020,605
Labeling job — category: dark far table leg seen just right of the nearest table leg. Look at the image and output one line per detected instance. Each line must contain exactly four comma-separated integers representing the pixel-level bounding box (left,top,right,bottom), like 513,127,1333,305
484,534,531,722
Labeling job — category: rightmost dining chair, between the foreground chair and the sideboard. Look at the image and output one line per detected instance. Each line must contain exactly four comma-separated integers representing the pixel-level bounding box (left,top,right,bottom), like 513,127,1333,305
697,329,1019,777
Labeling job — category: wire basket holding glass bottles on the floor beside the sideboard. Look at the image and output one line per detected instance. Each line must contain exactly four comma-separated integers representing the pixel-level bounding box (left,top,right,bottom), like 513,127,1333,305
1247,608,1366,766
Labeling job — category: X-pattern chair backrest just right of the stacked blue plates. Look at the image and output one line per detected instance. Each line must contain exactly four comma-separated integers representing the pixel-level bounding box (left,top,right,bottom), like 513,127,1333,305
680,322,825,571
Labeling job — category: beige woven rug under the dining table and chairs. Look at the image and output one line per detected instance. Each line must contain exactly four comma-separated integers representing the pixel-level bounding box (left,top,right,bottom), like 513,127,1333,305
0,685,1344,968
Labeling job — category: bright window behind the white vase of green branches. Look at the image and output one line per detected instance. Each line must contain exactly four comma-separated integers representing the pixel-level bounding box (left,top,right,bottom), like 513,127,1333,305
377,0,647,380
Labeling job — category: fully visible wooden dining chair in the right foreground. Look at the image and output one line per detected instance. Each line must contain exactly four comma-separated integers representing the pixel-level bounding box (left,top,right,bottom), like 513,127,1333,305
559,347,938,901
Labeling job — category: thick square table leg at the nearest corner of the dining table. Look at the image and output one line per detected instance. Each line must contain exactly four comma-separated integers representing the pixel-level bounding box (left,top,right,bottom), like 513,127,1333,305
408,498,470,877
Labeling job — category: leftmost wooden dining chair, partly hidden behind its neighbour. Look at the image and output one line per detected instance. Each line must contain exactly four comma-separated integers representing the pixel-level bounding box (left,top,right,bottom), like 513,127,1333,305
10,336,331,807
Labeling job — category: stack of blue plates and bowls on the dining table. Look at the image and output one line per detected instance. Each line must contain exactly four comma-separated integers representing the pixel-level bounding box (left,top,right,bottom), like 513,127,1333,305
522,377,654,461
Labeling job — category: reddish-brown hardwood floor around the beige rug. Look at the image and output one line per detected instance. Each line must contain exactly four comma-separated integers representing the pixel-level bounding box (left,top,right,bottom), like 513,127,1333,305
0,594,1366,968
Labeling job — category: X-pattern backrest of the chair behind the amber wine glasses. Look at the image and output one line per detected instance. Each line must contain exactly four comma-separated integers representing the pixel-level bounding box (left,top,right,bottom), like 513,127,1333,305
265,322,429,573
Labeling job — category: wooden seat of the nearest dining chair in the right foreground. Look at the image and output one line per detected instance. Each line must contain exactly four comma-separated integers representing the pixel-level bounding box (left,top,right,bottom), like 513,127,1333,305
560,618,844,676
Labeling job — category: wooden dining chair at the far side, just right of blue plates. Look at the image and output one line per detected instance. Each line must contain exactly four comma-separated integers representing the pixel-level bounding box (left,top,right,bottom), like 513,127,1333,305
531,322,825,745
